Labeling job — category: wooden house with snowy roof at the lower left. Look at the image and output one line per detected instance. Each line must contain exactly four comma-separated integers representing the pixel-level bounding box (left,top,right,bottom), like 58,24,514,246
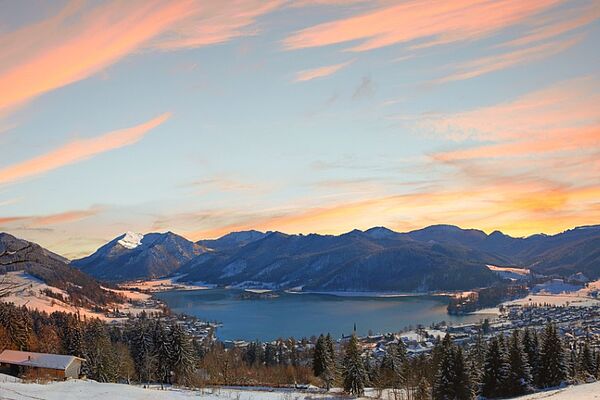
0,350,85,379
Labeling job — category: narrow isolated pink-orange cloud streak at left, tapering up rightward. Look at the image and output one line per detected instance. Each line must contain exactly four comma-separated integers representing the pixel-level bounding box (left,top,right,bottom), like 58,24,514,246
0,113,171,184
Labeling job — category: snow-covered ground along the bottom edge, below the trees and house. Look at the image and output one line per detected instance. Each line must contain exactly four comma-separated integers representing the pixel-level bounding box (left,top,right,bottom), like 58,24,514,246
0,375,600,400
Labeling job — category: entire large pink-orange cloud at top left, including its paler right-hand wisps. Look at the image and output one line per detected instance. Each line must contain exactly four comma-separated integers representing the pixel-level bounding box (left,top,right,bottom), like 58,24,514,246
0,0,281,111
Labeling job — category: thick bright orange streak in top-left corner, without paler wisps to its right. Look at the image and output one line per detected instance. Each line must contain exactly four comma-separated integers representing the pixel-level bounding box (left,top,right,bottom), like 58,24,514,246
0,1,190,110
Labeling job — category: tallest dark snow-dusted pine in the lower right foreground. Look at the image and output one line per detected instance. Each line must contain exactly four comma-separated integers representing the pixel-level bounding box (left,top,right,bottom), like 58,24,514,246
539,324,567,387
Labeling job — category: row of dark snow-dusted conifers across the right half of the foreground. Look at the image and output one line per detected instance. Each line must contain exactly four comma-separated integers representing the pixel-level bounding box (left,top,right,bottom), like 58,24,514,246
313,324,600,400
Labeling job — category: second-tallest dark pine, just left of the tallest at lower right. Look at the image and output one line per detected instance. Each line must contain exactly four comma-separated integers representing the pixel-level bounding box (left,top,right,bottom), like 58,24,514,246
506,330,532,396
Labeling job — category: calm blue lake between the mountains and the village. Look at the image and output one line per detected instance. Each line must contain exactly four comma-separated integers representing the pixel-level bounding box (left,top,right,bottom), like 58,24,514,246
155,289,496,341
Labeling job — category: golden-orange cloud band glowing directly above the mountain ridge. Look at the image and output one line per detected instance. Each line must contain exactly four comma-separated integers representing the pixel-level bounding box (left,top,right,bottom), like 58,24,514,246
188,182,600,240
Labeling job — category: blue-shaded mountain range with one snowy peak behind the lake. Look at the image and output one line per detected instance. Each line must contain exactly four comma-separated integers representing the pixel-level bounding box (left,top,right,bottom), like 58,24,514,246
72,225,600,291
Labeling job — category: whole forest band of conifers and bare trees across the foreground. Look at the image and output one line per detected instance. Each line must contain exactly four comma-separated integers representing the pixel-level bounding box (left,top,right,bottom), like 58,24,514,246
0,303,600,400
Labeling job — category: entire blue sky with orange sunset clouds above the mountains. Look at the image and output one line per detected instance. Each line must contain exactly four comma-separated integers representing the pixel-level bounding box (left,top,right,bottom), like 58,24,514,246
0,0,600,258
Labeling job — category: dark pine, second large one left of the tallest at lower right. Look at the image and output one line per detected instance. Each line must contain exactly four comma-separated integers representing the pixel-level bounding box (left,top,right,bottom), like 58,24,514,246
481,336,509,397
